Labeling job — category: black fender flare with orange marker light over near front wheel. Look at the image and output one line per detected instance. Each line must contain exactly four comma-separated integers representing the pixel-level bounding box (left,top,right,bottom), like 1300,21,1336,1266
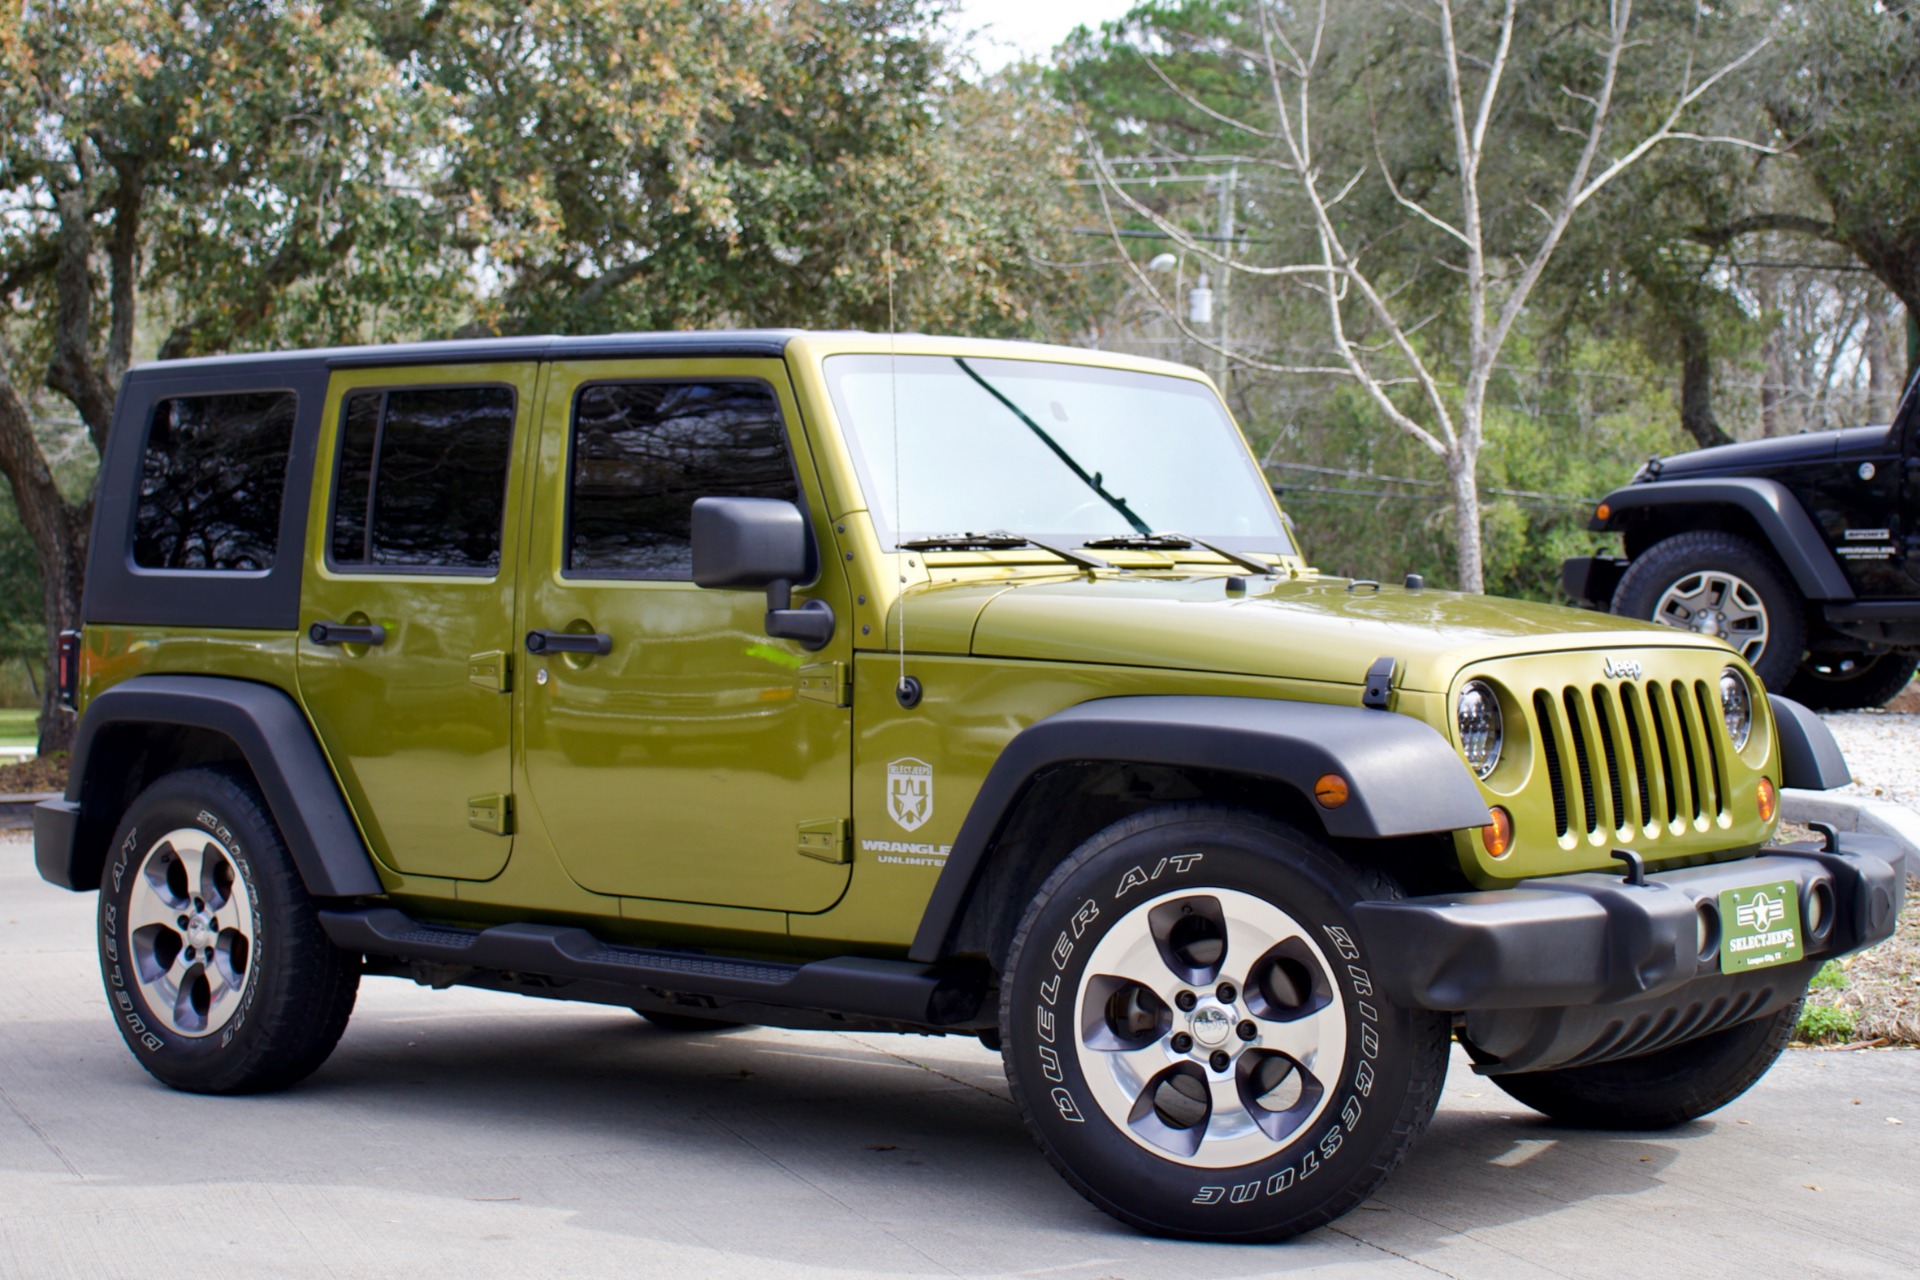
908,695,1488,963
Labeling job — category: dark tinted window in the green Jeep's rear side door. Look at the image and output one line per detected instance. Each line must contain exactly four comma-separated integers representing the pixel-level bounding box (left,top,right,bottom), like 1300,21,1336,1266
328,386,513,574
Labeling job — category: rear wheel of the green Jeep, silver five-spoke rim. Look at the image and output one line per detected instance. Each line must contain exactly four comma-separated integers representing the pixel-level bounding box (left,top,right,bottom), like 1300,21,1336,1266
100,768,361,1094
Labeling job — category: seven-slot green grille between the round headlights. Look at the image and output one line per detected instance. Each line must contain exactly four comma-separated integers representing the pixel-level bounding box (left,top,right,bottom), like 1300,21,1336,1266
1532,679,1732,841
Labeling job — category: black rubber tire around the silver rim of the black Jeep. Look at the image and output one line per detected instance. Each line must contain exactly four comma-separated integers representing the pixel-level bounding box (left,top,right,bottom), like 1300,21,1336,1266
1613,532,1807,693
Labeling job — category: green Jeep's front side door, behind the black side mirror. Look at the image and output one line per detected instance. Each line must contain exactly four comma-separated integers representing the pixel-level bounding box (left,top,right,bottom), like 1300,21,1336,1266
516,359,852,912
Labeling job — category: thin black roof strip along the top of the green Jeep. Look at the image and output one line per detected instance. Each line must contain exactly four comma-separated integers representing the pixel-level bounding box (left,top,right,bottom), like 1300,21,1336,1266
129,328,801,378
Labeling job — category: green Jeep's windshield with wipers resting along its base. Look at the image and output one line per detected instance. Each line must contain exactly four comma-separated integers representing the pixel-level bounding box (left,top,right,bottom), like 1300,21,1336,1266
826,355,1292,555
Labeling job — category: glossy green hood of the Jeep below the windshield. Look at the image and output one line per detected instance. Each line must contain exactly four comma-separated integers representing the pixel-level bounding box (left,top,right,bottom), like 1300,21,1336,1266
889,574,1724,693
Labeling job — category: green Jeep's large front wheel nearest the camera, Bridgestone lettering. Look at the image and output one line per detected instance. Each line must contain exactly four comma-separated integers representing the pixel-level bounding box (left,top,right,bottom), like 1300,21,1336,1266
1000,804,1448,1242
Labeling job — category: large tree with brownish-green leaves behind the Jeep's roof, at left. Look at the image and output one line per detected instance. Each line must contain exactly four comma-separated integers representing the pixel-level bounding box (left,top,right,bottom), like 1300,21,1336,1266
0,0,1073,750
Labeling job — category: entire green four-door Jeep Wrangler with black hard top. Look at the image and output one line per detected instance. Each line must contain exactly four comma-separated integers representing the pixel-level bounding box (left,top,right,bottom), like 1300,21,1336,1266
35,332,1905,1240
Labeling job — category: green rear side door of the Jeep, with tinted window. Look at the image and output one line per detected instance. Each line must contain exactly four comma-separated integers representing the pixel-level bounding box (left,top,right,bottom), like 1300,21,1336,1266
298,365,538,879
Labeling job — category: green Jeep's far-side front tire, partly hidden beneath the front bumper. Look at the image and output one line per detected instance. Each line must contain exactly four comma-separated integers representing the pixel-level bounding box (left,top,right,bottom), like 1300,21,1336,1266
1490,996,1805,1130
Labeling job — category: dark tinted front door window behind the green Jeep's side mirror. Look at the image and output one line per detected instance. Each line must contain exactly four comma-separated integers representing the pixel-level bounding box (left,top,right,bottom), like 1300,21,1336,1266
566,382,801,580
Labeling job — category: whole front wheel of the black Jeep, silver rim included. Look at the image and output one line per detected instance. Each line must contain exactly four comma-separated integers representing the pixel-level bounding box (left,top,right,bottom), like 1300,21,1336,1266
1613,532,1807,691
